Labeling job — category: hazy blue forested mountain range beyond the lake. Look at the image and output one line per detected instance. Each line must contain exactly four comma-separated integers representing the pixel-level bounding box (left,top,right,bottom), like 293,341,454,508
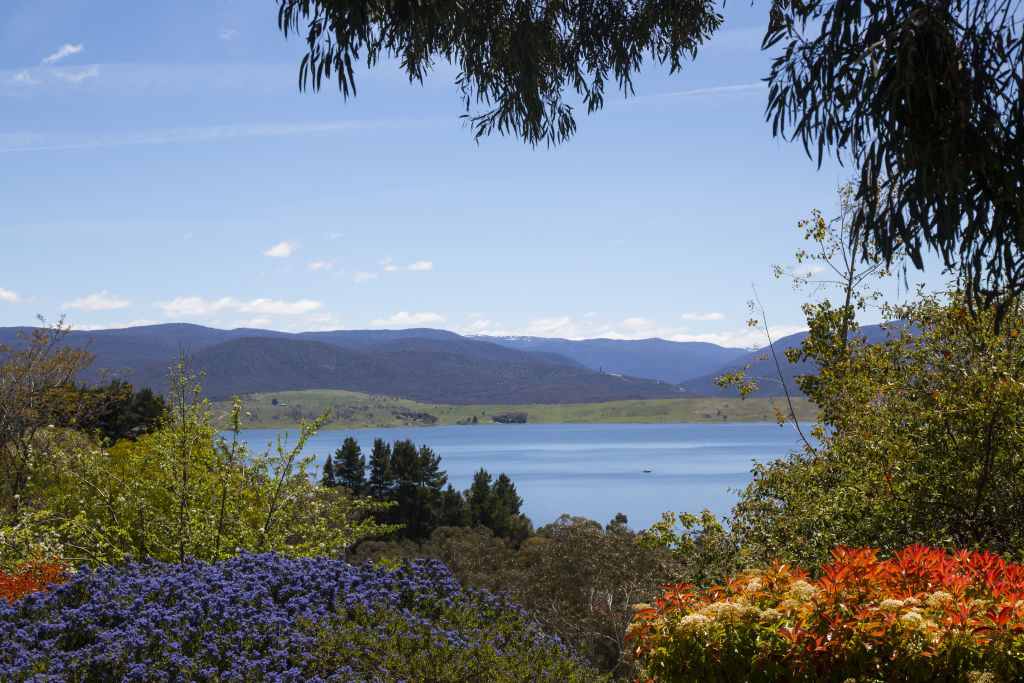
0,324,881,404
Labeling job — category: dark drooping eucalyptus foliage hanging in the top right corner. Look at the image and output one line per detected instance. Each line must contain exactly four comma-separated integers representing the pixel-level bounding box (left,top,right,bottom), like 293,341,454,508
763,0,1024,313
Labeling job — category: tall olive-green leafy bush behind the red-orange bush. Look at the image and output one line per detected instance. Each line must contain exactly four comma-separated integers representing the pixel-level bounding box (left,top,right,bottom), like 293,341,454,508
730,292,1024,566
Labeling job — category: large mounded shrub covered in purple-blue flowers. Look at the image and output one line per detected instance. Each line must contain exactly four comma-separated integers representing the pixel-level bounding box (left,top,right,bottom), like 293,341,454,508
0,554,603,683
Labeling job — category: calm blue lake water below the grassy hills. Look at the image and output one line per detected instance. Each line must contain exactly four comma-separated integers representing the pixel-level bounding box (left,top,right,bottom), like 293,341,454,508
235,423,798,528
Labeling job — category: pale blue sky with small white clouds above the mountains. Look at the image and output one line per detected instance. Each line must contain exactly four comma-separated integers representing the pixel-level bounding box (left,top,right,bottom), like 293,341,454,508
0,0,943,347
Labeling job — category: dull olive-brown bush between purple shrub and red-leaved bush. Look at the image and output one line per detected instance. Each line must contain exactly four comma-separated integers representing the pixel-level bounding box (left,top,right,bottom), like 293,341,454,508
349,515,675,679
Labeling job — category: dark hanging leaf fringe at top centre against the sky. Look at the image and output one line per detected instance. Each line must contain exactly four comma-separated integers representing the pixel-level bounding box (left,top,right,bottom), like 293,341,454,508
278,0,722,144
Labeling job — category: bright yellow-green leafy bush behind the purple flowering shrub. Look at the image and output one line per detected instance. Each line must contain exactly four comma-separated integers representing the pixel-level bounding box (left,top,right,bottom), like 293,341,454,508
0,361,393,565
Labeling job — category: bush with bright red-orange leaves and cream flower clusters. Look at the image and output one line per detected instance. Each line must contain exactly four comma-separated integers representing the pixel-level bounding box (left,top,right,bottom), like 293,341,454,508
631,545,1024,681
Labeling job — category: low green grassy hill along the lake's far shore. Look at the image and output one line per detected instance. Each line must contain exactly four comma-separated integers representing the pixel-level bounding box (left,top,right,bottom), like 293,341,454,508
213,389,814,429
